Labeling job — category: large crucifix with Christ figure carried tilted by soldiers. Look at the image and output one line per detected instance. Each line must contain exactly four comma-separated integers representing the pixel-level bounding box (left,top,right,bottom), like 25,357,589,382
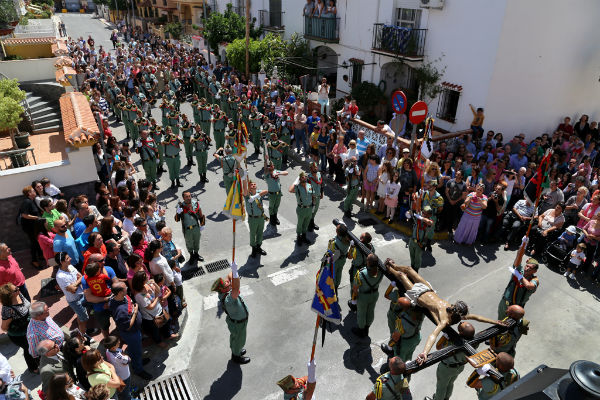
333,219,517,381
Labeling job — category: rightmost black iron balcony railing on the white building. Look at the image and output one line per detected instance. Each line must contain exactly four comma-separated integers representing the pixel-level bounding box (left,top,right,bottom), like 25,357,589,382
372,24,427,58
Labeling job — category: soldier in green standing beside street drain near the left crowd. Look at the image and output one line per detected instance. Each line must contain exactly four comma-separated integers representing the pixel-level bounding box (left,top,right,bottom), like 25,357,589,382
175,191,205,262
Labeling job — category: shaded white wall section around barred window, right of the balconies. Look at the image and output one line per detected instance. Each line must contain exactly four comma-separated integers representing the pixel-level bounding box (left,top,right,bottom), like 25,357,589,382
422,0,508,131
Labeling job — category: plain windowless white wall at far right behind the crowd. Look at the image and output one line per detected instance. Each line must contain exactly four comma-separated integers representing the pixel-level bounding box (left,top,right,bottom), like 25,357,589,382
484,0,600,138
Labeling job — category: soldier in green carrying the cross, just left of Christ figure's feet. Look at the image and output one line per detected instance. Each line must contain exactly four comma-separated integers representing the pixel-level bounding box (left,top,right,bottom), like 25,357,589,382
352,254,384,338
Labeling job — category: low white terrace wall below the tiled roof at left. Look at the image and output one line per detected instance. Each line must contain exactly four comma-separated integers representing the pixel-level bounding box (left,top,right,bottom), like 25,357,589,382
0,146,98,199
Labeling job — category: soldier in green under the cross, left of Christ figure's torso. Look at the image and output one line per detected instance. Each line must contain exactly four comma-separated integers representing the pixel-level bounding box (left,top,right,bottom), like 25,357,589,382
390,297,425,360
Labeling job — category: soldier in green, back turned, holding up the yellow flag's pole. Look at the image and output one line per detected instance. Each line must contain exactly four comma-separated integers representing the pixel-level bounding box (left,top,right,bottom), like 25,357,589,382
211,268,250,364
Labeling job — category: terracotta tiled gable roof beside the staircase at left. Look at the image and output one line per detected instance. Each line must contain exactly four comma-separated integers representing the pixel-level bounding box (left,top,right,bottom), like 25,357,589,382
60,92,99,147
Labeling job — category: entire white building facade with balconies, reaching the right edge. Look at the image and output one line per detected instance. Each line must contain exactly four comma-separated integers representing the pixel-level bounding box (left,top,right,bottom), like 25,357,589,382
215,0,600,138
